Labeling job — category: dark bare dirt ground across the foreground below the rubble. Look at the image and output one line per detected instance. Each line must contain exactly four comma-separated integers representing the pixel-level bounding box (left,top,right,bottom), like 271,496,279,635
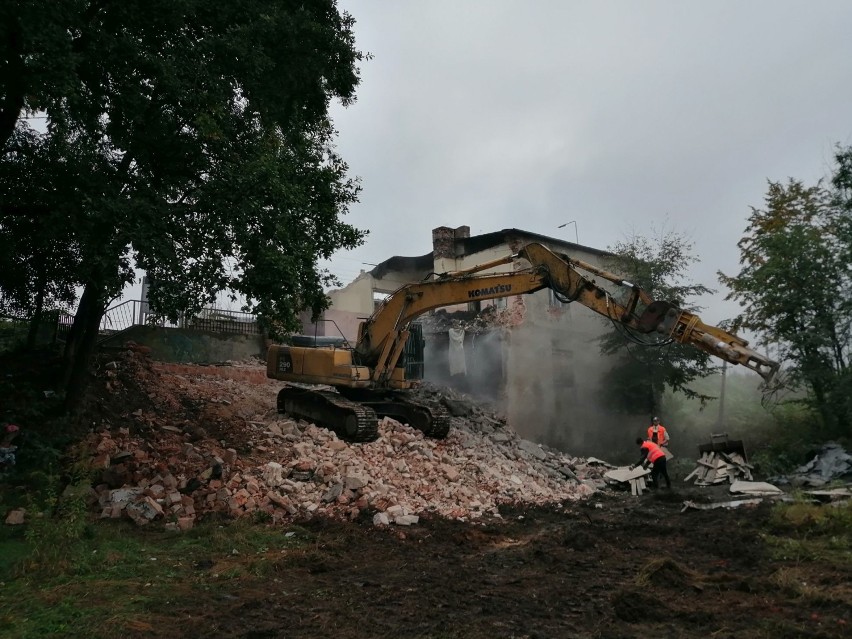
153,495,852,639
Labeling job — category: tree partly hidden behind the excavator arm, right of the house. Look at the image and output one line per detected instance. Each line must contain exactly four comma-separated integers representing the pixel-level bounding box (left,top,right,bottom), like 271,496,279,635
601,230,713,415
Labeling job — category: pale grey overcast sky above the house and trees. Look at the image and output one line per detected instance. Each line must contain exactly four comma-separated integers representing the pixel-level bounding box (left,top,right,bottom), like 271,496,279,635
322,0,852,323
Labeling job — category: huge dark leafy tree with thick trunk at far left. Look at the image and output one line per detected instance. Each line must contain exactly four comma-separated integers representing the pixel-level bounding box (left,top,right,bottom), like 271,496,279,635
0,0,364,416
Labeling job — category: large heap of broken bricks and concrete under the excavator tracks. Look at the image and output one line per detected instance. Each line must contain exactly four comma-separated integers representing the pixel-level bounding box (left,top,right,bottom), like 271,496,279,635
80,354,606,529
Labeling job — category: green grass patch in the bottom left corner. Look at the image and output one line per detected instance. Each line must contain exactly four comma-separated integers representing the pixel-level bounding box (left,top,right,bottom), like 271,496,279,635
0,508,315,639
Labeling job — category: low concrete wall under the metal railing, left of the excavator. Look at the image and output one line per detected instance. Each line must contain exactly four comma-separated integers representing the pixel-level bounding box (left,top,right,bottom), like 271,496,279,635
102,326,266,364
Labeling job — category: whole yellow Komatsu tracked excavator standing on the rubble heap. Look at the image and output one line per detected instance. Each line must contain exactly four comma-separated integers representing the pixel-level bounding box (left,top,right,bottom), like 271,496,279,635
266,243,778,442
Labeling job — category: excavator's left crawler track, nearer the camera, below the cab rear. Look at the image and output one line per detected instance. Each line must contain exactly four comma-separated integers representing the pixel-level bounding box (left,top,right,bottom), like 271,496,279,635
278,386,379,442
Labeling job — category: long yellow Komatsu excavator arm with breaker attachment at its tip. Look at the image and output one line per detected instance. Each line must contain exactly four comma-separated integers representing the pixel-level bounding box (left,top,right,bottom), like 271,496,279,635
355,243,778,385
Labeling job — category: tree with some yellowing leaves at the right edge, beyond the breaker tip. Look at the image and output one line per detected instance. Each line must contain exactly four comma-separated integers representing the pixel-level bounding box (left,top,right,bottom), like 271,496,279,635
719,149,852,434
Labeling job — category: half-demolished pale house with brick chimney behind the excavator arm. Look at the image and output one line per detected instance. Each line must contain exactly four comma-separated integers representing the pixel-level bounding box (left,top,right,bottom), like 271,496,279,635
305,226,646,455
